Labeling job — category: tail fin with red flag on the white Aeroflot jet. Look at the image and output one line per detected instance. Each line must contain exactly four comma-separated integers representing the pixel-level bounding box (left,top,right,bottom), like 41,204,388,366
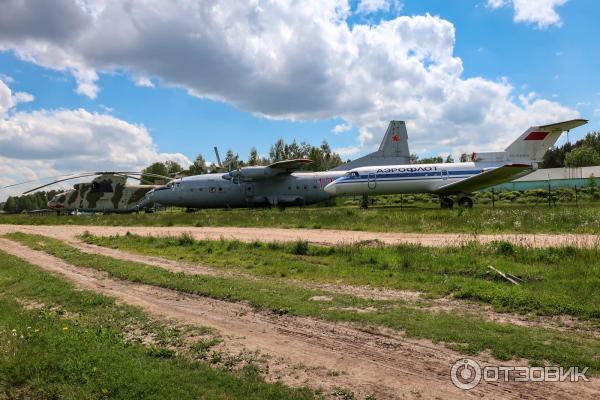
506,119,588,162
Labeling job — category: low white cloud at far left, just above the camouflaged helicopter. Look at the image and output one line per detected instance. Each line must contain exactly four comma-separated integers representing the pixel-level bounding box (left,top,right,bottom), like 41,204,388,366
0,80,190,199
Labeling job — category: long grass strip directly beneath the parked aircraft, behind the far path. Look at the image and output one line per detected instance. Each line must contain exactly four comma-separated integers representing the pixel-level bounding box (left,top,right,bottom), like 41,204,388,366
0,205,600,234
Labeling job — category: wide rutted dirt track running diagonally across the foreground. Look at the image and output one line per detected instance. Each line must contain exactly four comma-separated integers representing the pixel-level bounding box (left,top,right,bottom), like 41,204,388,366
0,239,600,399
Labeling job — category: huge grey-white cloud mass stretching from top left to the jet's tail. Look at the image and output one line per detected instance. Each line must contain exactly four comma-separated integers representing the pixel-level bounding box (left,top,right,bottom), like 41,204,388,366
0,0,578,162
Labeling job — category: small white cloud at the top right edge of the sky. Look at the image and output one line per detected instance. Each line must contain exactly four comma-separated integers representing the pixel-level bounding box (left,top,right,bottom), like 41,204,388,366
487,0,568,28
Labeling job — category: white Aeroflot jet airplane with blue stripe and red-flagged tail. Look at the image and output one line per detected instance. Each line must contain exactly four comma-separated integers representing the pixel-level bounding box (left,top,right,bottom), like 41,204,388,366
325,119,588,208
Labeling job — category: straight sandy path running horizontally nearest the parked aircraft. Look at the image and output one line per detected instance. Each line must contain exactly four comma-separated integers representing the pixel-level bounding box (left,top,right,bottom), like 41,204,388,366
0,225,600,247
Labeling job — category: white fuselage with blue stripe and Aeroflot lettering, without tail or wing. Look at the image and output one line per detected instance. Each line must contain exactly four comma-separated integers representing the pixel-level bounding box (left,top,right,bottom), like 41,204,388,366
325,162,501,195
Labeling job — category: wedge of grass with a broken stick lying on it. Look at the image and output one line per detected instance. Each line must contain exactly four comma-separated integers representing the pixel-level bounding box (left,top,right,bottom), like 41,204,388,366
84,234,600,321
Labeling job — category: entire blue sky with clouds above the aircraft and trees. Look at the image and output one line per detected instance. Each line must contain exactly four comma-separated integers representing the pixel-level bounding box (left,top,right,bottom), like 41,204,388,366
0,0,600,201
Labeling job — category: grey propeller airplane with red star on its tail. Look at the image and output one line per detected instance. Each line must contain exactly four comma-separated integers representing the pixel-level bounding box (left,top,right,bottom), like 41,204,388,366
139,121,410,209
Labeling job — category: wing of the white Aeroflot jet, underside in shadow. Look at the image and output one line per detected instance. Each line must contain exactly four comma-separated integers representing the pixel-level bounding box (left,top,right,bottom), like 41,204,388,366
435,164,532,195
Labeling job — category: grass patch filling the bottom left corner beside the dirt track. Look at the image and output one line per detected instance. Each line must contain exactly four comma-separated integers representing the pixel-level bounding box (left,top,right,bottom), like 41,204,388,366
0,252,314,400
